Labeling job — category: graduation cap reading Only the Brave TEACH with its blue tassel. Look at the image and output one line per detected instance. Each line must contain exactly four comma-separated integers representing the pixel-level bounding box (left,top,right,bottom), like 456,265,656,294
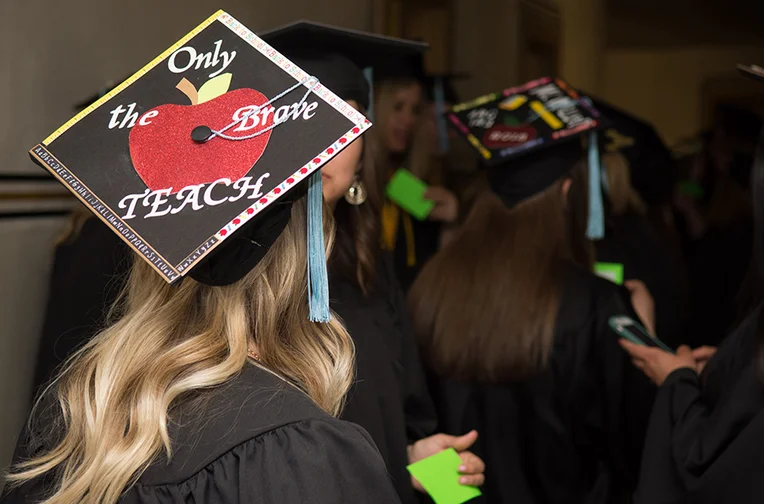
30,11,371,321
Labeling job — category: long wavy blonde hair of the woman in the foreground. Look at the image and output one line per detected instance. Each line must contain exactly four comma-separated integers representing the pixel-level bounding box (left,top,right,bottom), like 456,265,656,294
8,197,354,504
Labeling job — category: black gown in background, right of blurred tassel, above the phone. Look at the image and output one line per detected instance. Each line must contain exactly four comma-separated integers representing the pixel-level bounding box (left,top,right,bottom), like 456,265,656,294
595,214,686,348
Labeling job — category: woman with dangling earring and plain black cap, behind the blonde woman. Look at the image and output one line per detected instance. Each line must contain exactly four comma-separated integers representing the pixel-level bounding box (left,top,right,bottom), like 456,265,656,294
262,21,483,503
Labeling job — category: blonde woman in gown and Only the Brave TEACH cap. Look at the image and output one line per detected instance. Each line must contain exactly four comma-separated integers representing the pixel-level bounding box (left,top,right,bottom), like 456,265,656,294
0,11,398,504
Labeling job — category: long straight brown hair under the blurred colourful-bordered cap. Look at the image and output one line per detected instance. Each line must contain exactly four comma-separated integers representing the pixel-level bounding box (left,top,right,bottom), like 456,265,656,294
409,163,592,382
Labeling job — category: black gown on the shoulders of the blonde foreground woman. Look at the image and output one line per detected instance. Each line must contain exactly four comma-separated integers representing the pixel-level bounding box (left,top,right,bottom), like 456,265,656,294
0,365,399,504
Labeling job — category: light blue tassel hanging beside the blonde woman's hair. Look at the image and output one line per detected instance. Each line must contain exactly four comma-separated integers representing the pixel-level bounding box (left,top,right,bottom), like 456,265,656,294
308,170,331,323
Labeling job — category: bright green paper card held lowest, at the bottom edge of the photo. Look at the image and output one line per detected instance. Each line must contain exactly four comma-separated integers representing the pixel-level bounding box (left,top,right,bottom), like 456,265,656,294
406,448,482,504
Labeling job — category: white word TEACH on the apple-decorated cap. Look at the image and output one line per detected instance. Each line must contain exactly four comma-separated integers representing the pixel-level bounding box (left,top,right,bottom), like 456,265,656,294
119,173,270,220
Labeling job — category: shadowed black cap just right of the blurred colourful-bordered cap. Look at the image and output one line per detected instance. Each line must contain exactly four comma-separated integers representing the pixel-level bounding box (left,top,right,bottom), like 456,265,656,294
582,96,676,204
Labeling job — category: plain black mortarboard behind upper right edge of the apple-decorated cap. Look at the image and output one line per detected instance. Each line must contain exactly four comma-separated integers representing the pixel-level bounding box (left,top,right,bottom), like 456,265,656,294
260,21,427,110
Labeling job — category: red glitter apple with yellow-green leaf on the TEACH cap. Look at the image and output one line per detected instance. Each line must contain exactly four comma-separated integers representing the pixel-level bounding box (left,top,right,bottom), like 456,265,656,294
129,73,273,193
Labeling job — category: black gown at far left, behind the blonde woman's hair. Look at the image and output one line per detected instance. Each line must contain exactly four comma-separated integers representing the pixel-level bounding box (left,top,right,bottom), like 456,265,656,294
34,218,132,390
